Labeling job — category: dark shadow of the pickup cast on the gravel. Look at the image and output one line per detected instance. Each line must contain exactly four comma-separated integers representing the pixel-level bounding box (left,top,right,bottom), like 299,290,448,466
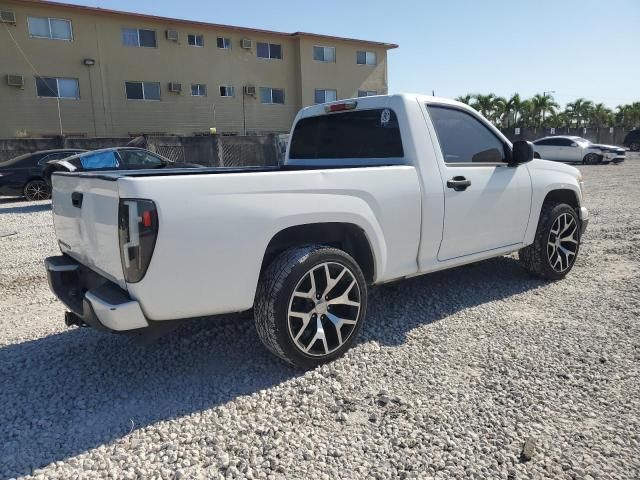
0,258,544,478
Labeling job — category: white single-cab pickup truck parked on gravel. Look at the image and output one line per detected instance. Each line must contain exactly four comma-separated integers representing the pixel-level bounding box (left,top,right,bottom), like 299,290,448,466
45,95,588,368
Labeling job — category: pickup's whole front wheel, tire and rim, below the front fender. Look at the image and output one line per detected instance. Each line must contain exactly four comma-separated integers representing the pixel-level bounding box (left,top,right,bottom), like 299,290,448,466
519,203,581,280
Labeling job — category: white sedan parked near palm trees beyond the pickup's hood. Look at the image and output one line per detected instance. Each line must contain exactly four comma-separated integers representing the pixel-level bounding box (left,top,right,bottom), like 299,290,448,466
533,135,626,165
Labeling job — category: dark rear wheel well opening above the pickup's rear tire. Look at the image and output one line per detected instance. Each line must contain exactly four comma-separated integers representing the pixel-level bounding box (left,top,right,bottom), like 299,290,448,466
260,222,377,283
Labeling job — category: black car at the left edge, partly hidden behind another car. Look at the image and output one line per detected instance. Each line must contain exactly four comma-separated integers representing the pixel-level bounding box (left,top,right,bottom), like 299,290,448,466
0,148,86,200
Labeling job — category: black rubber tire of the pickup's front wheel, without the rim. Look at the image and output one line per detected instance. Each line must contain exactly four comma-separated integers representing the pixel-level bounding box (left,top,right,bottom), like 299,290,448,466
518,202,581,280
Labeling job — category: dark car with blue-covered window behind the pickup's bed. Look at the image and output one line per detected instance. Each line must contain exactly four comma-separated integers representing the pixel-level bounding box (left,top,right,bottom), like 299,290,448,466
44,147,202,185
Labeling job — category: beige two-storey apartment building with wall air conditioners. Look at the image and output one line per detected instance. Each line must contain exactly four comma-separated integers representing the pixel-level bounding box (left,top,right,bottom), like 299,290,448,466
0,0,397,138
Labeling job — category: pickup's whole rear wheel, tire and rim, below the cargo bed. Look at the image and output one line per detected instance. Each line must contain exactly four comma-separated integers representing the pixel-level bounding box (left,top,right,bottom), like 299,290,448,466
254,245,367,369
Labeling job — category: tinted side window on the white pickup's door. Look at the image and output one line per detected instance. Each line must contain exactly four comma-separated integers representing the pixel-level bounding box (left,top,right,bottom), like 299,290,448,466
427,105,506,163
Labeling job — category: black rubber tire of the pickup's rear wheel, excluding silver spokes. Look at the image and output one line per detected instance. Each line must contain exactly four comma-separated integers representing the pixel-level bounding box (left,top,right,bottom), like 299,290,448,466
254,245,367,369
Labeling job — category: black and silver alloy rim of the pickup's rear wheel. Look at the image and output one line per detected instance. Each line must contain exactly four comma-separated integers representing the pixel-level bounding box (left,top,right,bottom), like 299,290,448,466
288,262,361,357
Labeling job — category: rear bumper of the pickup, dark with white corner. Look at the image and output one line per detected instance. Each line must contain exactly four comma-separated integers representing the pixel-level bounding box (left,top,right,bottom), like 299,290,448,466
44,255,149,332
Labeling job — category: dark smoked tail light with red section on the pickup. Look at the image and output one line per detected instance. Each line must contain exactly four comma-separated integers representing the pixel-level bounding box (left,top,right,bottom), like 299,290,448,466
118,199,158,283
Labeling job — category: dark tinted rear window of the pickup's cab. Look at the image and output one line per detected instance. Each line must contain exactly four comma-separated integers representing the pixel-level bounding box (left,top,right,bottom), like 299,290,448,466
289,108,404,166
